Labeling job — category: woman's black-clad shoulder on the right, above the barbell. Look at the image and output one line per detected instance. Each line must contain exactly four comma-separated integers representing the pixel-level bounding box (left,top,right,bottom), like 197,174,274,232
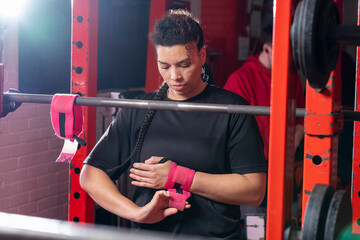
207,85,249,105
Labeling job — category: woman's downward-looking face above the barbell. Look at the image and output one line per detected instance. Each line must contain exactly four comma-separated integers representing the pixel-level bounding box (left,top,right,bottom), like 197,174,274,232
156,42,206,100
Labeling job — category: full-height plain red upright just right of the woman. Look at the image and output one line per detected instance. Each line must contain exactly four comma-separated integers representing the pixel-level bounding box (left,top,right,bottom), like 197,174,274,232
266,1,296,239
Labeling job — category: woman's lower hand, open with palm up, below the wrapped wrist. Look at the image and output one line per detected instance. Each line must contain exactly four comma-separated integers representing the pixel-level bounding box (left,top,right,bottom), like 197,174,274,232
135,190,190,223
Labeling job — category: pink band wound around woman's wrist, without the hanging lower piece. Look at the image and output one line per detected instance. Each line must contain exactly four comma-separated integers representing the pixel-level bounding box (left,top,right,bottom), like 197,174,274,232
165,162,195,191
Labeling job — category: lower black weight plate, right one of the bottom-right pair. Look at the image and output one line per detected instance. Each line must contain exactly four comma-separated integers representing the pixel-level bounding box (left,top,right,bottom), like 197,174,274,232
324,190,352,240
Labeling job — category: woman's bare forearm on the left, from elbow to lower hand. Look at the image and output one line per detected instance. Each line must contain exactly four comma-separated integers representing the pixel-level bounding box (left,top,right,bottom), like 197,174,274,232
80,165,138,221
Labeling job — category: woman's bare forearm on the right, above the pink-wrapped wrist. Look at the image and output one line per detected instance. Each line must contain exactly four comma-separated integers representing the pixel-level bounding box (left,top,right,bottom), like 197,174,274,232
190,172,266,206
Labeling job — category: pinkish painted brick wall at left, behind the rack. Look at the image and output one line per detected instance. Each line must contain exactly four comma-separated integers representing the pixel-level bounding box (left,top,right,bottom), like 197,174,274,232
0,21,69,220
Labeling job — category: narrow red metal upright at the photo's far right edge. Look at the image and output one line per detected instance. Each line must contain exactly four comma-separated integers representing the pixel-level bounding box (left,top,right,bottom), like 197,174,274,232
351,1,360,234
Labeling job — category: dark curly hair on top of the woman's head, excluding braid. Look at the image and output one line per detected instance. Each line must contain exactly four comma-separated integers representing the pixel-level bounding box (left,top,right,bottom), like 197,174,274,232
150,9,205,50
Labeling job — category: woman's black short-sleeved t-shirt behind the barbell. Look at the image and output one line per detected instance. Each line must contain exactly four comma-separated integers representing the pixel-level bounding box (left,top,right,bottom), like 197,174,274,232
84,85,267,238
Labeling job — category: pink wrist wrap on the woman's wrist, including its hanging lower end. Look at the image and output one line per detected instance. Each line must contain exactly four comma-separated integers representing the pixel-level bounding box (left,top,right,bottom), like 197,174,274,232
165,162,195,211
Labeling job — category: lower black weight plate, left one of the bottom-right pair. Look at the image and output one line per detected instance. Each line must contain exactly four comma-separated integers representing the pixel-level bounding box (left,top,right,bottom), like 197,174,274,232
301,184,334,240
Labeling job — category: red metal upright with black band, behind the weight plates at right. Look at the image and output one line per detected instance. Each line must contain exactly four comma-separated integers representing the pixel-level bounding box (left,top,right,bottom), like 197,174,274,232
302,0,343,219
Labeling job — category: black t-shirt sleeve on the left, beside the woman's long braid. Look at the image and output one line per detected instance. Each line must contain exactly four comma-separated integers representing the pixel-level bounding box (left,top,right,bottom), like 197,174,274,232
84,109,130,180
